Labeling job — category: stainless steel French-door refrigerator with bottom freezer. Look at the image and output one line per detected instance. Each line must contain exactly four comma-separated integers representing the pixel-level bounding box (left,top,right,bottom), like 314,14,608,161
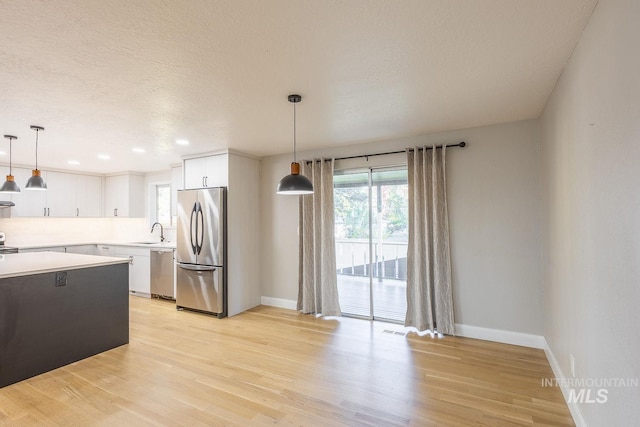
176,187,227,318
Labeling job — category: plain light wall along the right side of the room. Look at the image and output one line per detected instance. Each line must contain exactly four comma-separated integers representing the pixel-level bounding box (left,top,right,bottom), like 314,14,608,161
541,0,640,426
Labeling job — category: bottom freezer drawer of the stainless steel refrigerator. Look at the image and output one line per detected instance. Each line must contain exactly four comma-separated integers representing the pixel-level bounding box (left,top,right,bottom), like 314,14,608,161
176,264,226,317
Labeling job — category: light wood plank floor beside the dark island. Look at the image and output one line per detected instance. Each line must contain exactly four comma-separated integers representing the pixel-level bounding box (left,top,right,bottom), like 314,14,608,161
0,297,573,426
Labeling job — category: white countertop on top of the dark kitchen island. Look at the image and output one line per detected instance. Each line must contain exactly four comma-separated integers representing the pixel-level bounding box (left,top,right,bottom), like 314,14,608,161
0,252,129,279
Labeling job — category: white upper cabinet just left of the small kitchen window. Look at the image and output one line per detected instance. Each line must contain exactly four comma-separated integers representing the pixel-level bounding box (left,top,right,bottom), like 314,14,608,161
104,174,144,218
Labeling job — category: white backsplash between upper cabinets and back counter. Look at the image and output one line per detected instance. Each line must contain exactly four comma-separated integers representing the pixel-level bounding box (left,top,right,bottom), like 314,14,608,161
0,218,170,246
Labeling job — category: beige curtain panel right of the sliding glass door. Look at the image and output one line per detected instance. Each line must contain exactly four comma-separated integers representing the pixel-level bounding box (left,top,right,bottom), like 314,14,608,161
405,146,455,335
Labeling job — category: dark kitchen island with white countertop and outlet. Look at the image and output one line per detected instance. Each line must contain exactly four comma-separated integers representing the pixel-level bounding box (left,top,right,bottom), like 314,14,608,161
0,252,129,387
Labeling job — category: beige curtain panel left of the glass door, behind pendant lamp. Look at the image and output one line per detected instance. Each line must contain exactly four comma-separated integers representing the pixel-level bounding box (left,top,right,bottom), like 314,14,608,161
298,159,341,316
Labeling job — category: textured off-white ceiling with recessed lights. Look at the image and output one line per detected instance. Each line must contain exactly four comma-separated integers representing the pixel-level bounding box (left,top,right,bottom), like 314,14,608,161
0,0,596,172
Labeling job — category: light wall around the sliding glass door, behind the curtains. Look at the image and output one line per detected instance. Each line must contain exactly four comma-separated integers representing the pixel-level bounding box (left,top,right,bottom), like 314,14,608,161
261,121,542,335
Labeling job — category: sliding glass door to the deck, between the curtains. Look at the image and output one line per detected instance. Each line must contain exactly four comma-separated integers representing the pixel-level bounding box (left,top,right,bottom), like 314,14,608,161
334,168,408,322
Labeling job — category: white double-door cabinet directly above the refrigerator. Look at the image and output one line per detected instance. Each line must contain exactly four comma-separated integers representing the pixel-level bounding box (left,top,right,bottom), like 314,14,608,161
184,154,229,190
